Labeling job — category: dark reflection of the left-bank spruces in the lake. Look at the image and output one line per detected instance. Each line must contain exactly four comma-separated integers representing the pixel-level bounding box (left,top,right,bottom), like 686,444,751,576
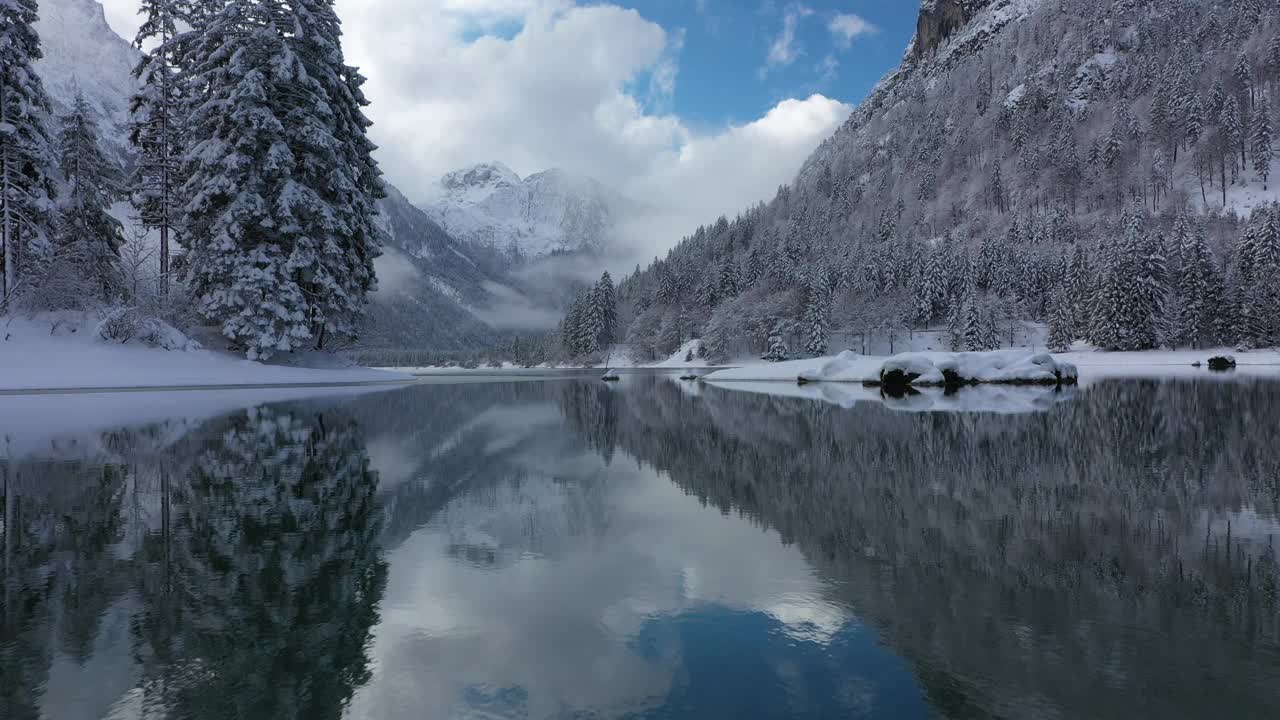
0,399,385,719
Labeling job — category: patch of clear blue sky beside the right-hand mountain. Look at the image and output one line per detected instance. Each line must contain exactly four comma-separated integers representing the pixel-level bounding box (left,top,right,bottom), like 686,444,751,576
621,0,918,126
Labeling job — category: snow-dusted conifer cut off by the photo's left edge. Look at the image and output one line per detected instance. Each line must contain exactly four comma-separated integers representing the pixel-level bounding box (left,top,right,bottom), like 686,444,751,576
0,0,54,299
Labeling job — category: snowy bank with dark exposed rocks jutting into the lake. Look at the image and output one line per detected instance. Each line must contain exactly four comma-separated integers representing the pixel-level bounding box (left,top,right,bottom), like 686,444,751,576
703,350,1078,387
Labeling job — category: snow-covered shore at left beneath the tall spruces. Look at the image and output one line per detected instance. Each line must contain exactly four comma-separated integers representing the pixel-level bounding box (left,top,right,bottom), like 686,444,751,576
0,314,412,392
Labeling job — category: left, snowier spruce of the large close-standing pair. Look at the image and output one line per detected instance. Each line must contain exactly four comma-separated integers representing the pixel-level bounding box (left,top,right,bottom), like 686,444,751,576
180,0,312,359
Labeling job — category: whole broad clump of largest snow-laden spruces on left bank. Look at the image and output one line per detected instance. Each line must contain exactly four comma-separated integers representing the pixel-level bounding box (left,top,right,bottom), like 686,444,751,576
182,0,381,359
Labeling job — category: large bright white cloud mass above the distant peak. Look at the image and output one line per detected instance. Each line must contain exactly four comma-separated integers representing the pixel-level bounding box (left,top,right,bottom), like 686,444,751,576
94,0,850,254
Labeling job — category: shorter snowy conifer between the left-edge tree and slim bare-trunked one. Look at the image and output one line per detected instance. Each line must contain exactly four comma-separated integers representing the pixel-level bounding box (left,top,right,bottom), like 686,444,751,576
58,95,124,301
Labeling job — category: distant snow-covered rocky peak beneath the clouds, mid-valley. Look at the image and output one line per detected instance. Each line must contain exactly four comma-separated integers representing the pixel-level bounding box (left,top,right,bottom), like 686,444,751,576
424,163,627,259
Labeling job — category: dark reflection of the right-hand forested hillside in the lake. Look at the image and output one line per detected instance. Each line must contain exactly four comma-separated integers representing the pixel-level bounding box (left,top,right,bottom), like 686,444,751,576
570,382,1280,717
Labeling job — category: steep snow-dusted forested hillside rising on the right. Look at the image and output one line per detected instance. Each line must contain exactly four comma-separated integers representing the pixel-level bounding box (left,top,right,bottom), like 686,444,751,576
561,0,1280,359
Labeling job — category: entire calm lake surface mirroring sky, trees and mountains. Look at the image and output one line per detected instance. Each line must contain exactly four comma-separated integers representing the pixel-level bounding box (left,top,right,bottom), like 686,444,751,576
0,377,1280,720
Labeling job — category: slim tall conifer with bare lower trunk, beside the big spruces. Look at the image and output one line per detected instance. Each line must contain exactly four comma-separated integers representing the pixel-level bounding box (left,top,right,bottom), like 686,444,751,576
129,0,189,295
